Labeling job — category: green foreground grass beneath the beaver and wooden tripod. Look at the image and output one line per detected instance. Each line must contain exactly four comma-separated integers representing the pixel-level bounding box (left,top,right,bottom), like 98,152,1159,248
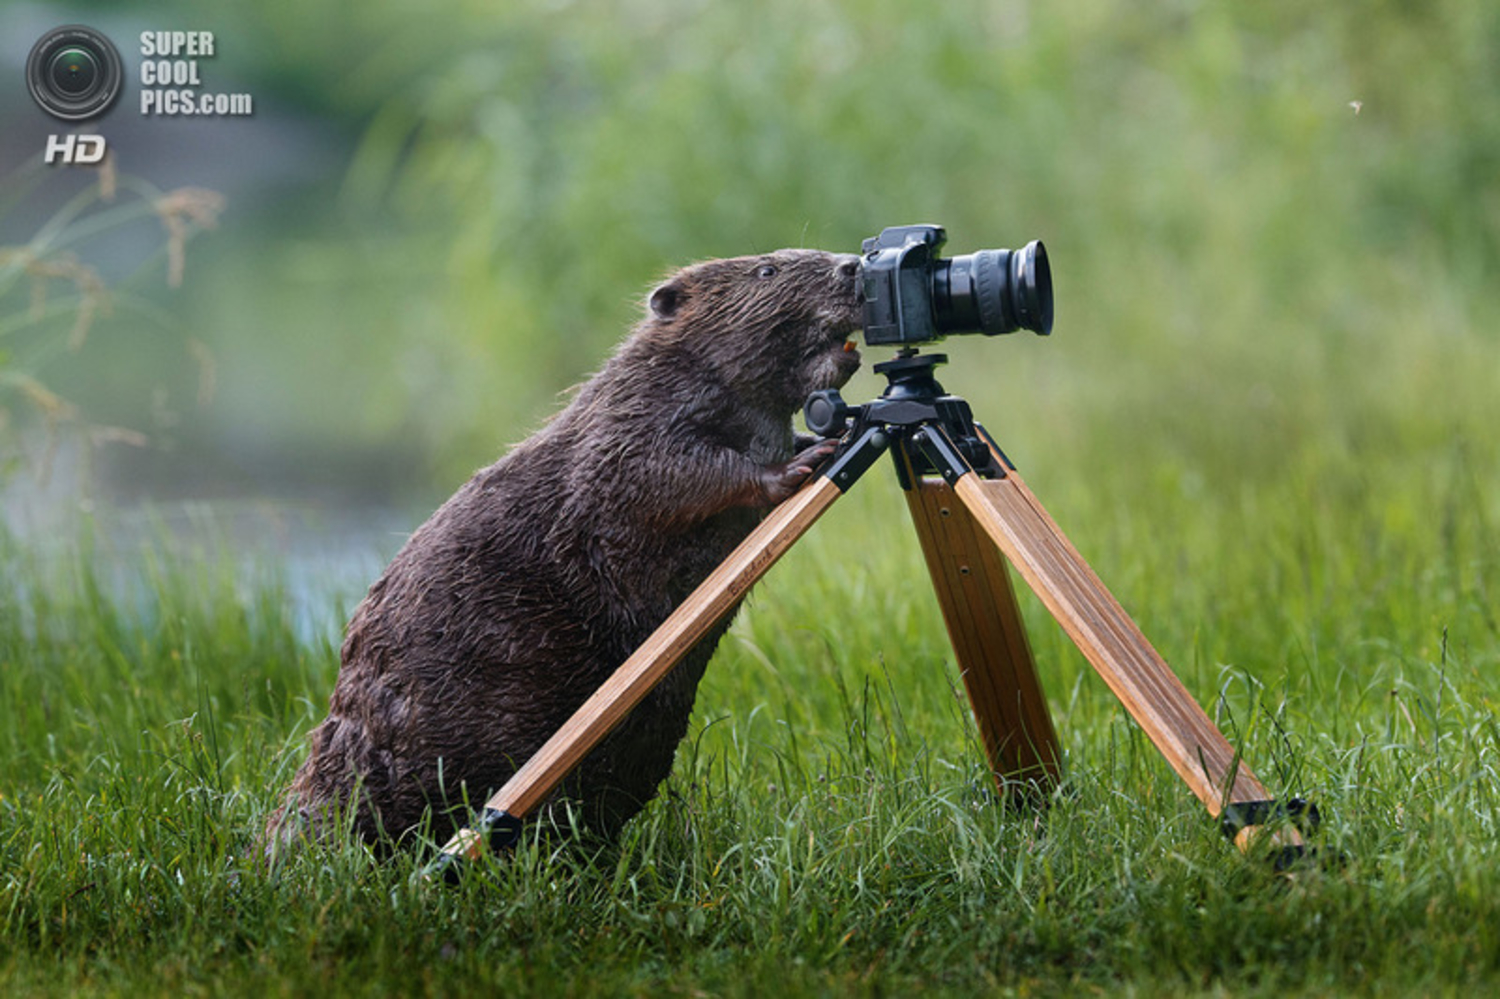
0,423,1500,996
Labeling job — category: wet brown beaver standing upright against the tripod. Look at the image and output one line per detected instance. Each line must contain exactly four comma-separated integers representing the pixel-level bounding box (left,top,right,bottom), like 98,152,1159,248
263,249,861,854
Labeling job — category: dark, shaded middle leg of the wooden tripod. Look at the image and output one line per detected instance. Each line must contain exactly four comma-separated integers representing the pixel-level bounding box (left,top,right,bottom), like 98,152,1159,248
906,480,1062,794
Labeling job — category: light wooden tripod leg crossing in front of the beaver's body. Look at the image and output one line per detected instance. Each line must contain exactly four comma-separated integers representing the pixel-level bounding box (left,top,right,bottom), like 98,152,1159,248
437,476,843,867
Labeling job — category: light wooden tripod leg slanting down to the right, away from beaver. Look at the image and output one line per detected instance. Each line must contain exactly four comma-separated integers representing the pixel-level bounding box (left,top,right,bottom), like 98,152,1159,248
954,458,1302,849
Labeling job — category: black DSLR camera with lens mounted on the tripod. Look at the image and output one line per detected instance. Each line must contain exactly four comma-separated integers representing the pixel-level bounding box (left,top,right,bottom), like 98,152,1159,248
860,225,1052,345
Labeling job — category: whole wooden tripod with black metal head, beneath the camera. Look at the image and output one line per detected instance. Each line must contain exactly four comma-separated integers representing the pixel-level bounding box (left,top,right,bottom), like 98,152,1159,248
429,351,1317,873
